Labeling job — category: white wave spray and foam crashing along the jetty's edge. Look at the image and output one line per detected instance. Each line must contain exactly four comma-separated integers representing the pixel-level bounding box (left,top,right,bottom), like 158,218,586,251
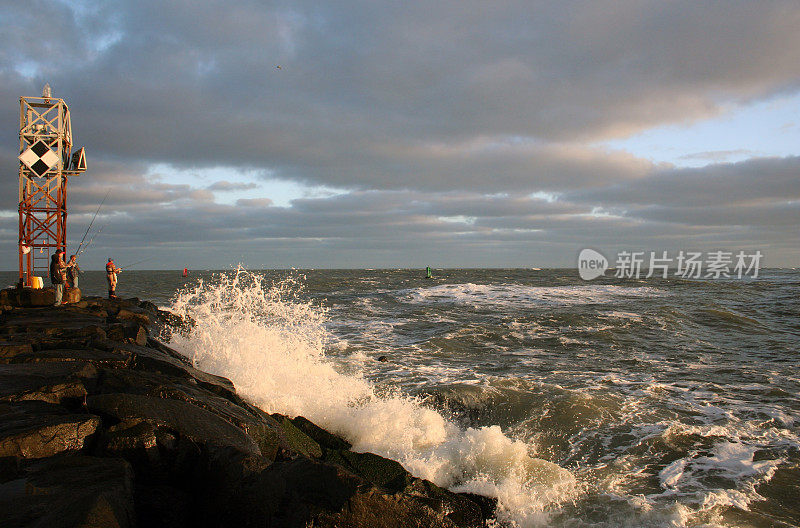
172,270,578,526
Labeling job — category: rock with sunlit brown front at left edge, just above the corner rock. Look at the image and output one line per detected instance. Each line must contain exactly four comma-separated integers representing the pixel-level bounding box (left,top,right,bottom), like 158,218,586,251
0,401,100,459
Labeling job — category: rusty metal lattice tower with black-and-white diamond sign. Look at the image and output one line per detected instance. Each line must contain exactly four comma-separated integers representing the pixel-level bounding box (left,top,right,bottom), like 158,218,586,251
19,89,86,286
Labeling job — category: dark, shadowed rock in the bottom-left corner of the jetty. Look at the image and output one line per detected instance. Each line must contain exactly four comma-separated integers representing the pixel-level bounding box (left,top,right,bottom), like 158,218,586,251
0,456,135,528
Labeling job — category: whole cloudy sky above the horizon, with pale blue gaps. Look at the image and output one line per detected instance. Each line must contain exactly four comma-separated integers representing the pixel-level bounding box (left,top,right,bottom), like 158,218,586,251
0,0,800,270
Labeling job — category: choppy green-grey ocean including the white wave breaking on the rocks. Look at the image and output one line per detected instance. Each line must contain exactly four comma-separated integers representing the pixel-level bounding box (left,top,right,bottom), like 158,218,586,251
0,269,800,527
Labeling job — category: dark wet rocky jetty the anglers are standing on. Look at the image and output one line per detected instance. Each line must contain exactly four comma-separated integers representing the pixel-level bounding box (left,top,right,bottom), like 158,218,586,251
0,295,494,528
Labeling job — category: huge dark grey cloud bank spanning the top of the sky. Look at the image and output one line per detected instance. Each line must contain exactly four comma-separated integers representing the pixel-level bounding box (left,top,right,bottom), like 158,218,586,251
0,2,800,189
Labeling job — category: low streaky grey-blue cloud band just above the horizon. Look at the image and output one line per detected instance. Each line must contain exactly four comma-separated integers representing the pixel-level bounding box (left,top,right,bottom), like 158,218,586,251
10,157,798,267
